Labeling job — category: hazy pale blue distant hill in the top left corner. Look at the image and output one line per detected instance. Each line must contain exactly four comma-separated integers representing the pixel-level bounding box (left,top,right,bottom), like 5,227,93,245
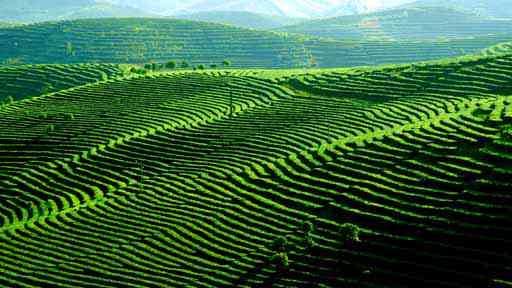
0,0,152,23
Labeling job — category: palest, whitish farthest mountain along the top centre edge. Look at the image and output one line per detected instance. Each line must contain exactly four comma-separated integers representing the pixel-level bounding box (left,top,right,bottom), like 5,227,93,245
100,0,413,17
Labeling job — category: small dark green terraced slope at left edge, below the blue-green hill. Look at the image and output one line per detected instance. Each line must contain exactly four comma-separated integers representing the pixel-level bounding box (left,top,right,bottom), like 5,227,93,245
0,64,123,102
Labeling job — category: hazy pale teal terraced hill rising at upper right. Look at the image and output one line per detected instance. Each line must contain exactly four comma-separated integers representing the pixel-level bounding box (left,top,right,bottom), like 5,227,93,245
277,7,512,40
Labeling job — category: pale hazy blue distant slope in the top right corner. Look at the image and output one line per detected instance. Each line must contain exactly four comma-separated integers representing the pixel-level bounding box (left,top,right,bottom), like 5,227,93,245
404,0,512,18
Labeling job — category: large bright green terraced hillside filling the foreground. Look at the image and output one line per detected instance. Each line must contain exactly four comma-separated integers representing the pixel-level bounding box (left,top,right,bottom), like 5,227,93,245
0,55,512,288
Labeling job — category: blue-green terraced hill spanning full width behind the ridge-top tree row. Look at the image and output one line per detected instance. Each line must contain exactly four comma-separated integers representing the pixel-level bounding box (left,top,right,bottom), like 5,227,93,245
0,18,512,68
